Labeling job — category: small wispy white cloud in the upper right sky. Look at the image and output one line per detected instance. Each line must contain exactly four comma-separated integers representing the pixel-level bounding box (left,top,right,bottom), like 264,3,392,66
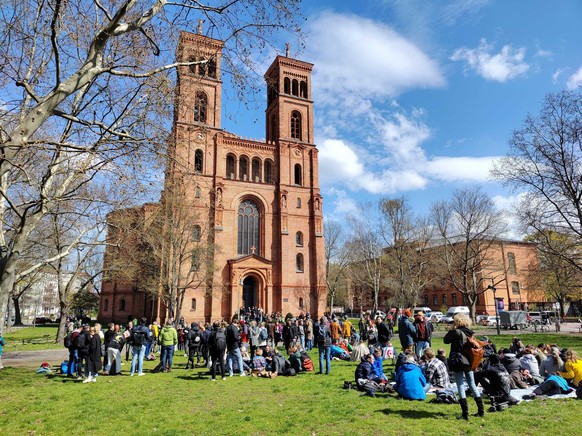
450,38,530,82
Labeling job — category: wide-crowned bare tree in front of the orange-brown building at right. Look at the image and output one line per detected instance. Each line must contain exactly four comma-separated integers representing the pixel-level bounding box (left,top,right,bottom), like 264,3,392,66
431,188,505,319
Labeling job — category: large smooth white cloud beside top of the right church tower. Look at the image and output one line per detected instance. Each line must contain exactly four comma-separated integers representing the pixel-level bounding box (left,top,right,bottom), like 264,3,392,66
306,12,445,104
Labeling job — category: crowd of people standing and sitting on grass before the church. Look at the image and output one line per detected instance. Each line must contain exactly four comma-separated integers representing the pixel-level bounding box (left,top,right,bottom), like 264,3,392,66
57,310,582,419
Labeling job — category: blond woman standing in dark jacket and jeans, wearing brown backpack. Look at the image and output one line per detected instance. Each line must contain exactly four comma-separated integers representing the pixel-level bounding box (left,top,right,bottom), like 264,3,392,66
443,314,485,421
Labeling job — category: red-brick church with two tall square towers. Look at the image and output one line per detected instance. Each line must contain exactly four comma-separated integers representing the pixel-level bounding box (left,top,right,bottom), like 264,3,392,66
99,28,326,322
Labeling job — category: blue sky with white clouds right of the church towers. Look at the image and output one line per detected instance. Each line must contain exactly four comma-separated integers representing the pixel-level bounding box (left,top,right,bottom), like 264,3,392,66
221,0,582,232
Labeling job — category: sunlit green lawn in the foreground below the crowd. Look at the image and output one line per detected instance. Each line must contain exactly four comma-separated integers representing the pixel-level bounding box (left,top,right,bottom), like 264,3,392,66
0,334,582,435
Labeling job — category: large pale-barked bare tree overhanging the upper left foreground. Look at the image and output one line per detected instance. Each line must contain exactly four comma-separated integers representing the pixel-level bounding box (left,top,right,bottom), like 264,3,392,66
0,0,299,332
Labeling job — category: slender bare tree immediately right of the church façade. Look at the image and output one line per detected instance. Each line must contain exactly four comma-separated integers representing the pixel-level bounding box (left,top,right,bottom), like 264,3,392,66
324,221,349,313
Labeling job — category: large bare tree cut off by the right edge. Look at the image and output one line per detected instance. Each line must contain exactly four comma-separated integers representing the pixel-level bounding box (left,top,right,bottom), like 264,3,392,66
492,88,582,270
